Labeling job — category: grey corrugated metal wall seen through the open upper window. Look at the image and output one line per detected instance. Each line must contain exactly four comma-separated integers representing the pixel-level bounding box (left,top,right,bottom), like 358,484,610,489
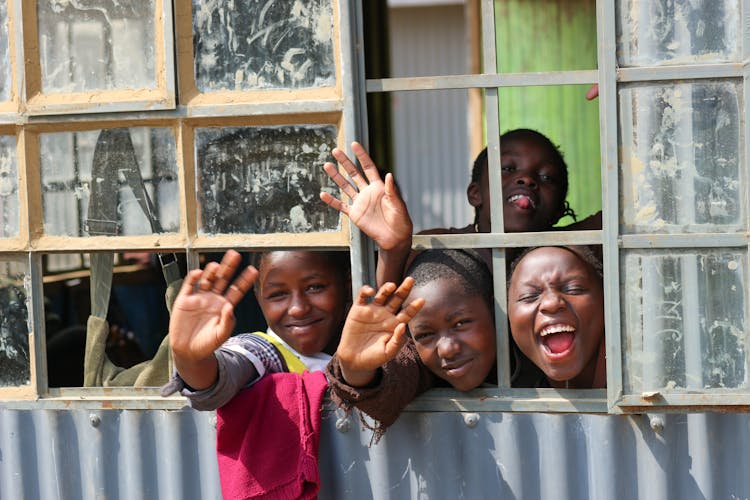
389,5,474,231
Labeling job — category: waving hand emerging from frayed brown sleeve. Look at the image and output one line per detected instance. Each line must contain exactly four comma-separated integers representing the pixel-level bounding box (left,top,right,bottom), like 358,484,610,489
336,277,424,387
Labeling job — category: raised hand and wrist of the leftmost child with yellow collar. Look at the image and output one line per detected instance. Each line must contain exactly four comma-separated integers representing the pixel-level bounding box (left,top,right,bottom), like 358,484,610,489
169,250,258,390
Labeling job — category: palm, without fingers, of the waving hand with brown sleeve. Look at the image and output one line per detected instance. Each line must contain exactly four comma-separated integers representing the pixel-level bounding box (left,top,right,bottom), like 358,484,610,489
337,303,400,370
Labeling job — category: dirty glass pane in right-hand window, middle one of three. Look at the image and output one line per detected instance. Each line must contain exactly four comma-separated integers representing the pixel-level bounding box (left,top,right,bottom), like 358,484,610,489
619,81,748,233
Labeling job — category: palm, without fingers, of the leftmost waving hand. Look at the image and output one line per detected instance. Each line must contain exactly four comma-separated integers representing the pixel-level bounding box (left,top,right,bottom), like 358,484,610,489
169,291,231,359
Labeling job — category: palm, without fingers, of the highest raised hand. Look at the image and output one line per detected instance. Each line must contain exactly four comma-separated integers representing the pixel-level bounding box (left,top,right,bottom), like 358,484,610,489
349,181,412,250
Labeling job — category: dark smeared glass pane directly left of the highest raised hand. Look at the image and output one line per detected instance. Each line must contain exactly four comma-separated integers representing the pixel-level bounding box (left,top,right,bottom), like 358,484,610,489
195,125,340,234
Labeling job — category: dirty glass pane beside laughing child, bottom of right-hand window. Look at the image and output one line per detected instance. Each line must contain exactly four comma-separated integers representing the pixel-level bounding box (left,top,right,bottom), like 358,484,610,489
621,249,748,393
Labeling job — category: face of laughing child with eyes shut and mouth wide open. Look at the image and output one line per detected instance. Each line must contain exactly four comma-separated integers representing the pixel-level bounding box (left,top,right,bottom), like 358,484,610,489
508,247,604,381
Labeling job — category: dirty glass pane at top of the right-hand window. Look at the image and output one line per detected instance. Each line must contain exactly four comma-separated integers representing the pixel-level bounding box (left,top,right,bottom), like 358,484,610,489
617,0,742,66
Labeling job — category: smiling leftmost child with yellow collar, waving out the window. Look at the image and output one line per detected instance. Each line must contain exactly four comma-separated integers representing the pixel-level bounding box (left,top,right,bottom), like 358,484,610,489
163,250,350,410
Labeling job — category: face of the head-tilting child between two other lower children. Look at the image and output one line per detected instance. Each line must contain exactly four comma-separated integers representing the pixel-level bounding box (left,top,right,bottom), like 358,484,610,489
409,280,496,391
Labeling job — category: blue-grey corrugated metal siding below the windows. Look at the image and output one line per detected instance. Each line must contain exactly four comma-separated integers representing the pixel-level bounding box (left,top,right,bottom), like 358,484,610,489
0,409,750,500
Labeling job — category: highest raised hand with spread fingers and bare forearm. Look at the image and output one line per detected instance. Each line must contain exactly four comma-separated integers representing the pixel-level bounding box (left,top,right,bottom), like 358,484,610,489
320,142,413,286
